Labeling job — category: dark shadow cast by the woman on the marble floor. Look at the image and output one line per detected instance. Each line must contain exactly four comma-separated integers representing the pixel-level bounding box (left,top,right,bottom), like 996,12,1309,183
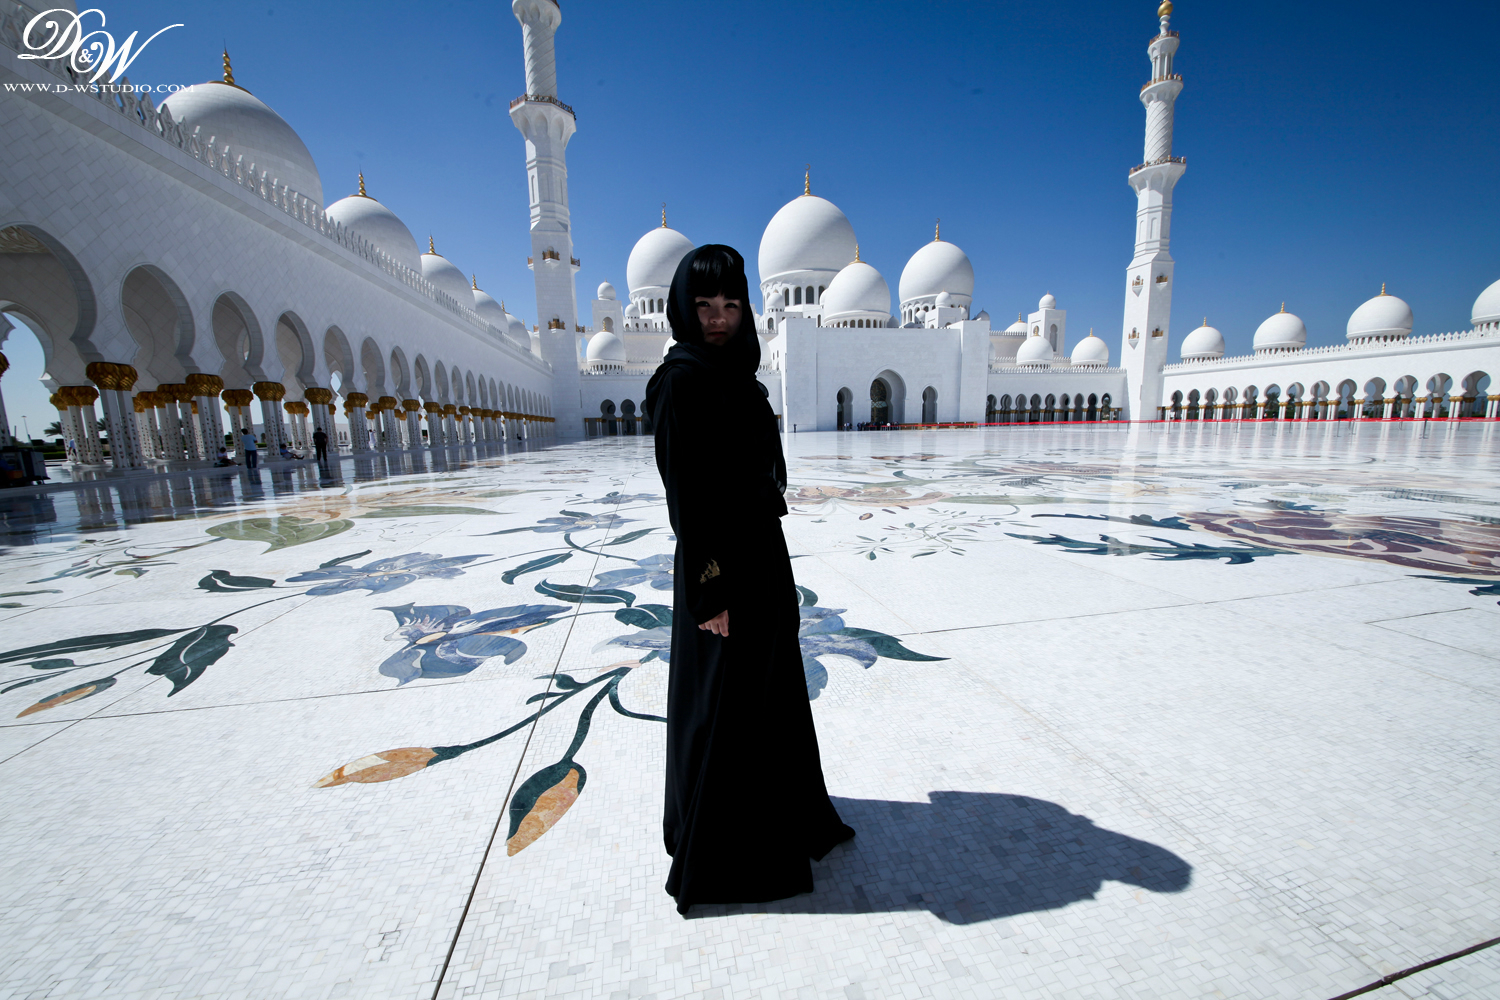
689,792,1193,924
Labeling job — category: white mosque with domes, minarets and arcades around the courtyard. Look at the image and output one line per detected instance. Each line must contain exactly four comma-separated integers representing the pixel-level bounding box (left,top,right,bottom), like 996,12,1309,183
0,0,1500,468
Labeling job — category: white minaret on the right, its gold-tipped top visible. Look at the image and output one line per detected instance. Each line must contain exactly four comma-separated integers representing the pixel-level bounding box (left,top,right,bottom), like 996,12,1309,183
1121,0,1187,420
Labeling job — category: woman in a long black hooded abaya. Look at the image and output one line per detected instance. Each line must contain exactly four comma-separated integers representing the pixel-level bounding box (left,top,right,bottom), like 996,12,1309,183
647,244,854,913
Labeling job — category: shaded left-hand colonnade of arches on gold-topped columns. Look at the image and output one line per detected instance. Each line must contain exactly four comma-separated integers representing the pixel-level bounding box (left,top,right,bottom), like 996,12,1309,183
0,223,554,468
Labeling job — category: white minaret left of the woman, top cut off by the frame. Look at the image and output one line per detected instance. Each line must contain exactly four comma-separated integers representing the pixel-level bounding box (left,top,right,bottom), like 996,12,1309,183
510,0,584,438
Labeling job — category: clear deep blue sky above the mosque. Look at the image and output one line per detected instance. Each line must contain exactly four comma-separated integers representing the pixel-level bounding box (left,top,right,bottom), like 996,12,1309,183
5,0,1500,430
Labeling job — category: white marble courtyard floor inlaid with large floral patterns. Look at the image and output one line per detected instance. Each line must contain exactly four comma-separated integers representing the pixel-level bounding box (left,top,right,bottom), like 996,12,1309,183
0,423,1500,1000
